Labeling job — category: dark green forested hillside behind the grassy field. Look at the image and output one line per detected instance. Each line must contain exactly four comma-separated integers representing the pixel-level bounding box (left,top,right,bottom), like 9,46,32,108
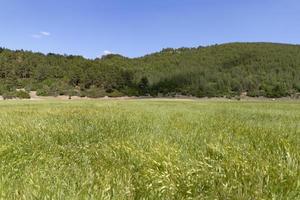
0,43,300,98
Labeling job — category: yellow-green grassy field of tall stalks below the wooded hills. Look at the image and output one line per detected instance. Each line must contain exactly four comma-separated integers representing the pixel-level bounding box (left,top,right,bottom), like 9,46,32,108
0,100,300,200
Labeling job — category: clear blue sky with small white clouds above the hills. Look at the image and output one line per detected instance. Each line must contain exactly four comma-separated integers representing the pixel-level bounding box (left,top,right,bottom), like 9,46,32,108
0,0,300,58
